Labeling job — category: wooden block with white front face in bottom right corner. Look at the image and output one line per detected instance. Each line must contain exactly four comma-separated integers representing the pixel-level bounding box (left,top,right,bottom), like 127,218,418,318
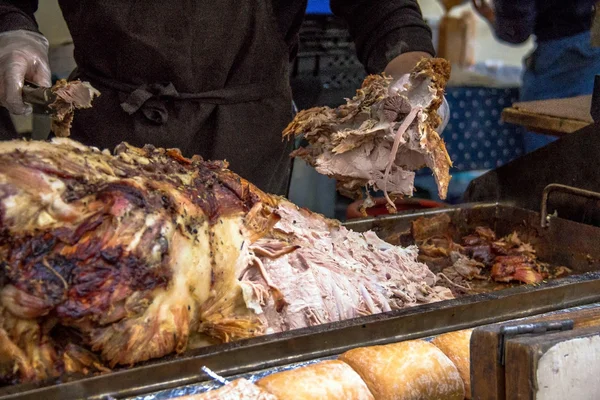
506,325,600,400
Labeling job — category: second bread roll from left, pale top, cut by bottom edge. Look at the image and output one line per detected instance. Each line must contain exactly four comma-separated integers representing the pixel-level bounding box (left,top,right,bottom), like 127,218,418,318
256,360,373,400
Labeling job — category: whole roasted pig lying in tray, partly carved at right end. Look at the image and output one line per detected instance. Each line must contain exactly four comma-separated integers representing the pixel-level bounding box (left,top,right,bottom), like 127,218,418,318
0,139,452,380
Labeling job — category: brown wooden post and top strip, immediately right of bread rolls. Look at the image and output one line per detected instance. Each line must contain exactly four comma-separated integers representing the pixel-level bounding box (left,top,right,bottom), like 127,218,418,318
471,299,600,400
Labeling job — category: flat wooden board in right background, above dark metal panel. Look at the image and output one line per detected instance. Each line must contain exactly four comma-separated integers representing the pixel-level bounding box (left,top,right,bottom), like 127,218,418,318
502,96,594,136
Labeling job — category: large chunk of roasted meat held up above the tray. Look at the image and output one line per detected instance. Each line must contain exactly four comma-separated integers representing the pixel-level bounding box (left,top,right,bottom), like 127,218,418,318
283,59,451,209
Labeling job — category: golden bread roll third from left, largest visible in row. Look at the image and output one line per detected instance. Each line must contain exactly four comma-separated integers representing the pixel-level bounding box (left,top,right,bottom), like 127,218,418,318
340,340,465,400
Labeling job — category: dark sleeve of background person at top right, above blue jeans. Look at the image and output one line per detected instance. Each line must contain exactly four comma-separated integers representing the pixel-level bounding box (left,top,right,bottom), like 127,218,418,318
494,0,537,44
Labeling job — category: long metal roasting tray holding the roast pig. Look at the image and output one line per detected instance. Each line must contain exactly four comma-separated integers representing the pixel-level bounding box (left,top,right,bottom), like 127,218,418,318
0,204,600,399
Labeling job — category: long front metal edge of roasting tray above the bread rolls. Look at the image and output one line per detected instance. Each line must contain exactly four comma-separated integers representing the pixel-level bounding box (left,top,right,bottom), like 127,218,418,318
0,272,600,400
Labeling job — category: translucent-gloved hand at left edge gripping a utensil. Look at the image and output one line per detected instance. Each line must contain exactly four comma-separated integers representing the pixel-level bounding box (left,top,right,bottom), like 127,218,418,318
0,30,52,114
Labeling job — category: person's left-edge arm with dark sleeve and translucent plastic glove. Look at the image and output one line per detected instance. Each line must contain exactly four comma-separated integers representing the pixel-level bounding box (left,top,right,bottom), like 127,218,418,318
0,0,52,114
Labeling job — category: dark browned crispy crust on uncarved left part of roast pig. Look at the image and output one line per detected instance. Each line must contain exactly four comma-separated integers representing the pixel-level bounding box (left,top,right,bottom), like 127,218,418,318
0,141,280,380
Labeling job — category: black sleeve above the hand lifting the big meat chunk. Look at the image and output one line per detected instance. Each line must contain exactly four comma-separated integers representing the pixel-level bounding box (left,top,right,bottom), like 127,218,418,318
330,0,435,73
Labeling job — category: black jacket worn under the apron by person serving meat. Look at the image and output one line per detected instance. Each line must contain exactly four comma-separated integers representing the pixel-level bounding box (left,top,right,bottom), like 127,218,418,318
0,0,434,73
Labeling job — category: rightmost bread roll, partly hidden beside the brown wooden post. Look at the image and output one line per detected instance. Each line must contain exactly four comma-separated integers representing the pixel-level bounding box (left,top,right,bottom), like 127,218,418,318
432,329,473,399
